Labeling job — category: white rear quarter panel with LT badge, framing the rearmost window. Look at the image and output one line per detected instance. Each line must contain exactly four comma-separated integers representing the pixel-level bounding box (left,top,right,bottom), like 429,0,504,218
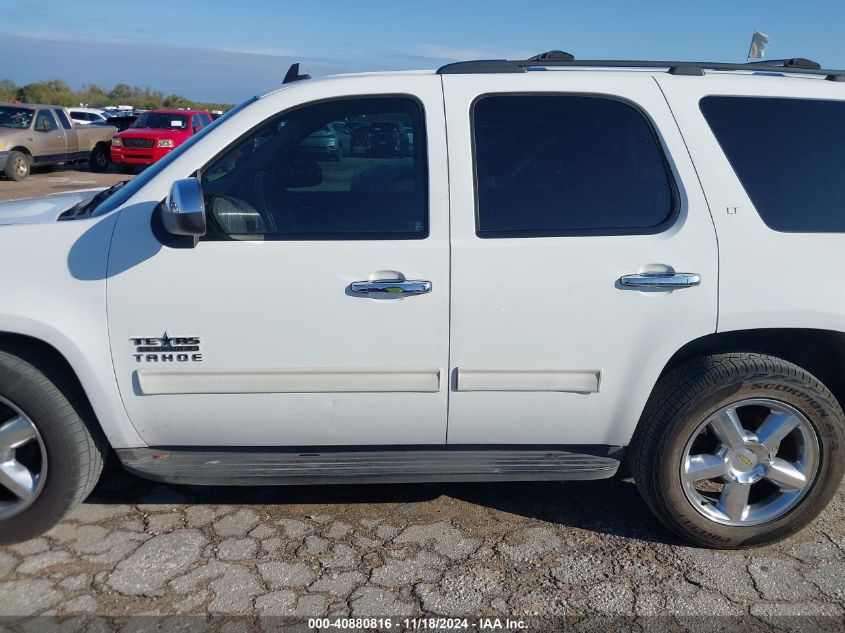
658,73,845,332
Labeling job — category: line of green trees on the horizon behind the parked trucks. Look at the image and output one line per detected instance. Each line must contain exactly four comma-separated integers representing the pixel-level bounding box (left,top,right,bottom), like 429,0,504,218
0,79,232,110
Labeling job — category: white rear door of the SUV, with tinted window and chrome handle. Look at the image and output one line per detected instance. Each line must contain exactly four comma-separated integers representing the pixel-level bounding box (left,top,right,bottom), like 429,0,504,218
443,71,718,445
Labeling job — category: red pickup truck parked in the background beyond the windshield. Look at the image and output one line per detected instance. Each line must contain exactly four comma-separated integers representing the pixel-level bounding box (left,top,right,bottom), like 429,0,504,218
111,110,212,172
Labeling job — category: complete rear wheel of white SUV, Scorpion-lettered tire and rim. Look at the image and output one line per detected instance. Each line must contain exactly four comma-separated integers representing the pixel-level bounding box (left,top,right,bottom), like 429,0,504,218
631,353,845,548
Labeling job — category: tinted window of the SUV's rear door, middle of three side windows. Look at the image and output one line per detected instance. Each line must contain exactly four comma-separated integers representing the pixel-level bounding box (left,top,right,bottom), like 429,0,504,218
473,95,674,237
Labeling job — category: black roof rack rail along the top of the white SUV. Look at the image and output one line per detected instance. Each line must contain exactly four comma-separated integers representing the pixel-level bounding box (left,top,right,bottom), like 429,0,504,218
437,51,845,81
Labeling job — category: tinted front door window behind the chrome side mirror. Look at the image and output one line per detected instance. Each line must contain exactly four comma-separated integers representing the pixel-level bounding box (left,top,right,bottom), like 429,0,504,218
201,97,428,240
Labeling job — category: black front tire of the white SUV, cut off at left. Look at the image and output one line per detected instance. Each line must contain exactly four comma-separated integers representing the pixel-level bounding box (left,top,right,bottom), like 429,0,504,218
0,348,106,544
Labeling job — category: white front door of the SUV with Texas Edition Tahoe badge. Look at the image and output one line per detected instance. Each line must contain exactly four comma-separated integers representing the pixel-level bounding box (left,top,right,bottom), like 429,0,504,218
108,76,449,447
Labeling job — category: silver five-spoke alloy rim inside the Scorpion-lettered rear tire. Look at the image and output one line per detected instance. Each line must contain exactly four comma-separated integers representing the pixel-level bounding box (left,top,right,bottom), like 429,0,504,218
680,398,821,526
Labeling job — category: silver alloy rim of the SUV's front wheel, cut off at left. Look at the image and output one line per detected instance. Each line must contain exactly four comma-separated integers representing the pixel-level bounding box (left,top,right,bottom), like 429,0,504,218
0,397,47,521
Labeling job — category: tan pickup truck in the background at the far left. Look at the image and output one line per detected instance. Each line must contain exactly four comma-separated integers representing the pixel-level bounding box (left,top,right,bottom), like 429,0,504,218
0,104,117,180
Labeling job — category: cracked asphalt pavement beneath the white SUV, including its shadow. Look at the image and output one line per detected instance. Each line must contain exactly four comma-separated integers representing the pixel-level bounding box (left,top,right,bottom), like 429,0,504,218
0,468,845,631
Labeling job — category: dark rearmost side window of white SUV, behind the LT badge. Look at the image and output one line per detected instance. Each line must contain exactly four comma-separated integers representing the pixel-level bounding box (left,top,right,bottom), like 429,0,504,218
701,96,845,233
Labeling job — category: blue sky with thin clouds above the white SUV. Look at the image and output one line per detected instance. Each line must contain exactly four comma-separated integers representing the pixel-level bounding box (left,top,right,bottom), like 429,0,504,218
0,0,845,103
